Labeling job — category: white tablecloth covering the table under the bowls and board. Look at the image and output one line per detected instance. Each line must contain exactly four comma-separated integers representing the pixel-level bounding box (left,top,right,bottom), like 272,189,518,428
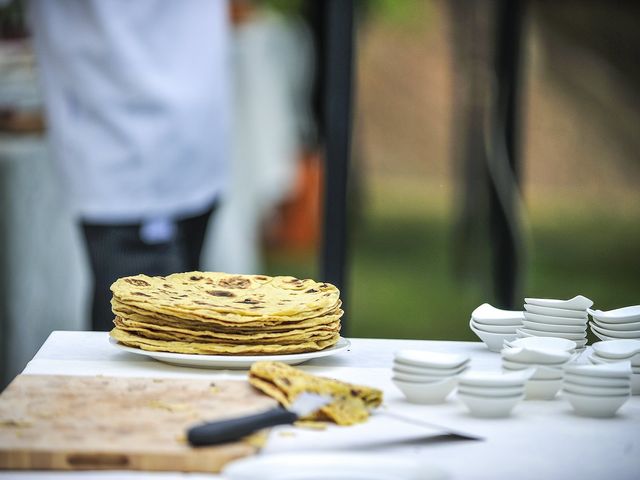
0,331,640,480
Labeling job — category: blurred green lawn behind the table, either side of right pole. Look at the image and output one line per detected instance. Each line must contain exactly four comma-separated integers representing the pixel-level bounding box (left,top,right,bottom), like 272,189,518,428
269,180,640,340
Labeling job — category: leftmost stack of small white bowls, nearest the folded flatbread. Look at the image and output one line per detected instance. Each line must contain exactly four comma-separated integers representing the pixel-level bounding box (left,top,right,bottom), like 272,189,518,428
392,350,469,403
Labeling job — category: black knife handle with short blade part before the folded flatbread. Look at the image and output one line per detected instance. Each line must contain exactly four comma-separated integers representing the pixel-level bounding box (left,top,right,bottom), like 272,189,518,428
187,392,333,447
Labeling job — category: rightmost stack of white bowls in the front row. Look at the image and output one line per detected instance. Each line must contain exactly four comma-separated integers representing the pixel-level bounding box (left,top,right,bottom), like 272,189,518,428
562,361,631,417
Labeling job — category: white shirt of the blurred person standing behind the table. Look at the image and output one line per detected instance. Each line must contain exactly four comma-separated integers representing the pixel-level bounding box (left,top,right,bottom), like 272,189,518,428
29,0,230,223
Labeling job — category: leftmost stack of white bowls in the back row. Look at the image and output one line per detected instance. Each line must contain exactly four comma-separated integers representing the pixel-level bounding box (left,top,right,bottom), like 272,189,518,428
469,303,524,352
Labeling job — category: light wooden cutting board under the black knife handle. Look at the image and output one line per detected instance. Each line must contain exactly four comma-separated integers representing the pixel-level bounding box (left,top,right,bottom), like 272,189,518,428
0,375,277,472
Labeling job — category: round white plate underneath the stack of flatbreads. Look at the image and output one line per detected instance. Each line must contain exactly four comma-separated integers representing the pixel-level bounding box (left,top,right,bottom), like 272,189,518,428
109,337,351,369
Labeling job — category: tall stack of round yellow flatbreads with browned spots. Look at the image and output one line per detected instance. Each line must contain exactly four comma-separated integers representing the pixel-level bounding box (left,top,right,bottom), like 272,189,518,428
110,272,344,355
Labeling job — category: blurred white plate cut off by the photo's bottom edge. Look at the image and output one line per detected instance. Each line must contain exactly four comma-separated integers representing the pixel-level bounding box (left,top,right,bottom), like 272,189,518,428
222,452,450,480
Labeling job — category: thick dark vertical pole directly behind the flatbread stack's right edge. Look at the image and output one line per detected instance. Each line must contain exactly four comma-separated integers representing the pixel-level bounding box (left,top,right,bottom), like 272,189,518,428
321,0,354,328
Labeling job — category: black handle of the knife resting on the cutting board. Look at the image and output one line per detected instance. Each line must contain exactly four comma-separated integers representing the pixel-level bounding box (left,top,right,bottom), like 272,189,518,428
187,407,298,447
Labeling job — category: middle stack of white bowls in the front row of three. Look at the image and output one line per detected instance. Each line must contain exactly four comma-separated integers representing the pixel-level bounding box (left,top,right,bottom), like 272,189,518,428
458,368,534,418
